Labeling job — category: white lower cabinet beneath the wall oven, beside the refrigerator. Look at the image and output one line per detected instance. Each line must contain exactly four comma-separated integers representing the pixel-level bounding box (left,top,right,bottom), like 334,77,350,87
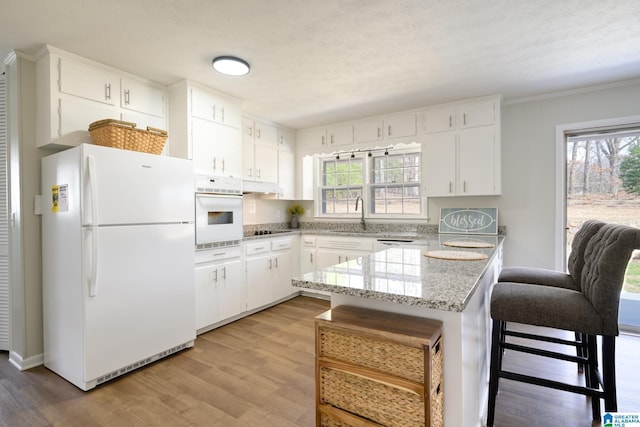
195,246,246,331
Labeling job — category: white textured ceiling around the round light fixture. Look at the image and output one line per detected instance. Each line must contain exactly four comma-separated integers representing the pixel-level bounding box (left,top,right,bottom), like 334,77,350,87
0,0,640,129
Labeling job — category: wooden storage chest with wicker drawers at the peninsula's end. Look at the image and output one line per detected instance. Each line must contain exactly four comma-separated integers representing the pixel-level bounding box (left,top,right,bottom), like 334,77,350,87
316,306,444,427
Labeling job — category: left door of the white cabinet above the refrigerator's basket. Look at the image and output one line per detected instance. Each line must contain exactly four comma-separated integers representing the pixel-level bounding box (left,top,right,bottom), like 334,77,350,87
59,58,119,105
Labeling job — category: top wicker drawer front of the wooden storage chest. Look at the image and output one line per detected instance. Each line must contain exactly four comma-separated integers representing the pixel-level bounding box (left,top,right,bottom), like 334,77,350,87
317,326,424,384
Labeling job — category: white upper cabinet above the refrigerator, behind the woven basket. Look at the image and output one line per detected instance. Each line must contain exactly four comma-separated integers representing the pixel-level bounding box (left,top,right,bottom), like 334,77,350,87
36,46,167,147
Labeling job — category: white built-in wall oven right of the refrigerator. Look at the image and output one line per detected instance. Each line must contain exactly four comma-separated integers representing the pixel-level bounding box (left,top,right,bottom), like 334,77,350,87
195,175,243,249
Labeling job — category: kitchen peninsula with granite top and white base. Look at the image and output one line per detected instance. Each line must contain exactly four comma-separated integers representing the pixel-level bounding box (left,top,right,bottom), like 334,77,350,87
293,234,503,427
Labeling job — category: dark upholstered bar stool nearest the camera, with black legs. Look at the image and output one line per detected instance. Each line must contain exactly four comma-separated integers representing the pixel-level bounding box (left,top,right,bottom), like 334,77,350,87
487,224,640,426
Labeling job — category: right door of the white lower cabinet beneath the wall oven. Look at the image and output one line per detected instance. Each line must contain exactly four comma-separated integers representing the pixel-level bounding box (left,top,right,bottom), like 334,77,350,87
217,259,247,320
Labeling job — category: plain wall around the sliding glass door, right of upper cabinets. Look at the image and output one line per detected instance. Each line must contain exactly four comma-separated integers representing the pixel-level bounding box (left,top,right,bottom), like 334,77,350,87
498,81,640,268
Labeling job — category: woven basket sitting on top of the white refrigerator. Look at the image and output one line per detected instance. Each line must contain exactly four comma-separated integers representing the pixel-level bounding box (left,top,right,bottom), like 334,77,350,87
89,119,167,154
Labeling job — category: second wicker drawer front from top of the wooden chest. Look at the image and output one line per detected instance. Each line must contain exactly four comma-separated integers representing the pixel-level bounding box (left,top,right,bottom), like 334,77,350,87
319,366,425,426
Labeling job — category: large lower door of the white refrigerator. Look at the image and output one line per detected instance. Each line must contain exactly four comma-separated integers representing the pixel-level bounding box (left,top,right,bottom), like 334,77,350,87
83,224,196,380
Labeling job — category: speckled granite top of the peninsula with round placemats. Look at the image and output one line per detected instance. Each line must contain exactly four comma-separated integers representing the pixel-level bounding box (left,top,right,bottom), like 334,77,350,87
292,233,504,312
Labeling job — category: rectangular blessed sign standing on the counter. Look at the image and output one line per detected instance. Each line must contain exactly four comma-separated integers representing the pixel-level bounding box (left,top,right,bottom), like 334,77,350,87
438,208,498,234
